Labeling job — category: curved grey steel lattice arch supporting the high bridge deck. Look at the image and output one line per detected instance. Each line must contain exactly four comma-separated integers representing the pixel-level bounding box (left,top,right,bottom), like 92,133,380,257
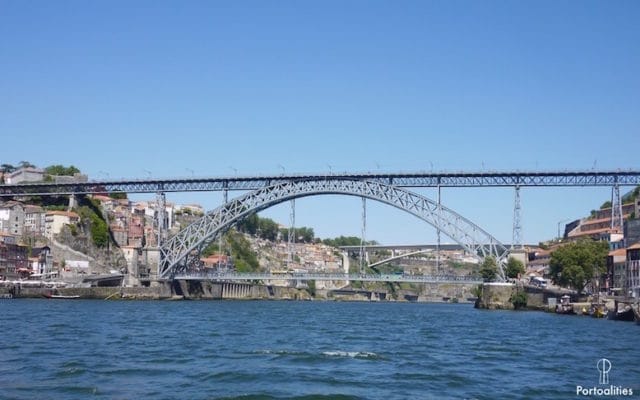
158,177,509,280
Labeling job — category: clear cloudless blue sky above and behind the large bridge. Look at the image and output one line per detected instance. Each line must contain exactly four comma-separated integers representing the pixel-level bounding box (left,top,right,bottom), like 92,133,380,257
0,0,640,243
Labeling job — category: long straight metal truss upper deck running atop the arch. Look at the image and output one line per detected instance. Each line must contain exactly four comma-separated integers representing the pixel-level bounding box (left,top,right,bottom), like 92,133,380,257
0,171,640,197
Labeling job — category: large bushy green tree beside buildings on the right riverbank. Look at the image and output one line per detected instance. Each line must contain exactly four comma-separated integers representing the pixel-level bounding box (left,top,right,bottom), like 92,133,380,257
549,240,609,293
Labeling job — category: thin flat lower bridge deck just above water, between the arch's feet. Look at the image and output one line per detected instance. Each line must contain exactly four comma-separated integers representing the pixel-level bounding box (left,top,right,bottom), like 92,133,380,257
173,271,482,284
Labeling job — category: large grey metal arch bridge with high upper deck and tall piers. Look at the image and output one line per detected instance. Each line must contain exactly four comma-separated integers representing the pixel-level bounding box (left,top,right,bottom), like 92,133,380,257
0,170,640,280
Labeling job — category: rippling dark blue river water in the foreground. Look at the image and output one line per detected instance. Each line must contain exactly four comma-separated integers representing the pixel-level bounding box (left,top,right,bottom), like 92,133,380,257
0,299,640,399
